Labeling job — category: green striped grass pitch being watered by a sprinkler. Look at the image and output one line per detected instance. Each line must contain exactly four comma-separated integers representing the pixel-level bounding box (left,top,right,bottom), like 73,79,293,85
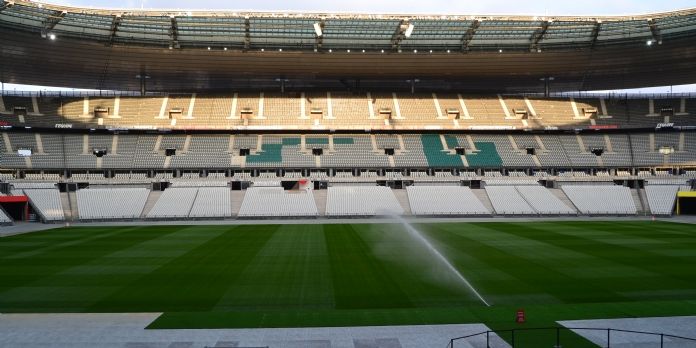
0,222,696,346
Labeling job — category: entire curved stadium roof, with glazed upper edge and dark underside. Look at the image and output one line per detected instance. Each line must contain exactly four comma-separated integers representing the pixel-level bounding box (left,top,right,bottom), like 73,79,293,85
0,0,696,90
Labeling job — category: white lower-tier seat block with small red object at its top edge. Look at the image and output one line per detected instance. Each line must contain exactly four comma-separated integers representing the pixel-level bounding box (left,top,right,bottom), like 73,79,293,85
238,187,319,217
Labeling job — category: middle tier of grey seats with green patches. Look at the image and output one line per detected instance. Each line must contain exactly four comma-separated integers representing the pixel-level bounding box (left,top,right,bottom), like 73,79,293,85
0,132,696,169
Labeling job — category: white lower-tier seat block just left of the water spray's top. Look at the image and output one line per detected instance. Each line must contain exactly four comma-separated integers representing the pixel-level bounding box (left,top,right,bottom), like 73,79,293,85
326,186,404,216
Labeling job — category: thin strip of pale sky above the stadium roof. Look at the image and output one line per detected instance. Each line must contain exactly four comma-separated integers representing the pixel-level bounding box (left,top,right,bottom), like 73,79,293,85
42,0,696,15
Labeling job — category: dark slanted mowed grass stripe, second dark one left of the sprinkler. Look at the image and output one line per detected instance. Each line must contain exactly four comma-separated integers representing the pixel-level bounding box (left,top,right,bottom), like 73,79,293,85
85,225,277,312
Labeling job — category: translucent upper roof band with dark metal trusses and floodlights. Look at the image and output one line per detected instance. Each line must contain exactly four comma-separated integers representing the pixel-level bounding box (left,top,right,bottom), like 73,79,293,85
0,0,696,52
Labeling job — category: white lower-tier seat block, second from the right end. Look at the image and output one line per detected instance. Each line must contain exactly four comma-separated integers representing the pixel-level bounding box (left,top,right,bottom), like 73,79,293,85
561,184,637,215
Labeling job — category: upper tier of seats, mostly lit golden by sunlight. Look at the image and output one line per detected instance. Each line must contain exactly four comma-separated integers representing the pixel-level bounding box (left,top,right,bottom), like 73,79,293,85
0,92,696,130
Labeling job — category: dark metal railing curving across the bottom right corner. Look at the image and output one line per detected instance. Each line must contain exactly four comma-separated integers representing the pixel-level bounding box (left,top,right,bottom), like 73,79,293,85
447,327,696,348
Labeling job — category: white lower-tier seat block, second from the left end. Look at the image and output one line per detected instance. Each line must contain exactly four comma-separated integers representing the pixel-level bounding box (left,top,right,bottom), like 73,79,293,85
77,188,150,220
